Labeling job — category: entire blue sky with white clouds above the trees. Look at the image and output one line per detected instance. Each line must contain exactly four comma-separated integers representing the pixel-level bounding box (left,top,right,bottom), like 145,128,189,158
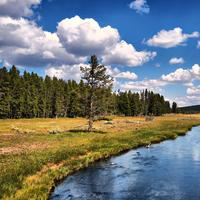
0,0,200,106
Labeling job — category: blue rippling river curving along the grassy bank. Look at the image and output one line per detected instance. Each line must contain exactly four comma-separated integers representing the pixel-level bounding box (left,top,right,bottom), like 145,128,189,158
50,126,200,200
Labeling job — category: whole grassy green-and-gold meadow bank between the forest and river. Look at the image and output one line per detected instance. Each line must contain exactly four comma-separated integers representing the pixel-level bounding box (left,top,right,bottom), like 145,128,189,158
0,115,200,200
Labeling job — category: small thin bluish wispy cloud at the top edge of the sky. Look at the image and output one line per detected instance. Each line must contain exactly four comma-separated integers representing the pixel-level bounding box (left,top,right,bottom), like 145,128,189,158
129,0,150,14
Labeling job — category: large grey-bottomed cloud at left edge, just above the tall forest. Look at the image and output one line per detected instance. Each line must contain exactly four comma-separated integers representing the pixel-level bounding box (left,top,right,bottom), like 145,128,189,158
0,17,85,67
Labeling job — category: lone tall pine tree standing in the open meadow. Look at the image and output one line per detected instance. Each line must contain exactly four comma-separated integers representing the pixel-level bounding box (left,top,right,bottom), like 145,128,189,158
80,55,113,132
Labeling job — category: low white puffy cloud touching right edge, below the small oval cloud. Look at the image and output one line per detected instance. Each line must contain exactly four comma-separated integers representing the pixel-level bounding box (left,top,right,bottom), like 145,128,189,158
161,64,200,83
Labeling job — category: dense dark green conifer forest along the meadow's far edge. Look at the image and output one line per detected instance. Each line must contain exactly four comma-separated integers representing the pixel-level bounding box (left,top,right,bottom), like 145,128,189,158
0,66,174,118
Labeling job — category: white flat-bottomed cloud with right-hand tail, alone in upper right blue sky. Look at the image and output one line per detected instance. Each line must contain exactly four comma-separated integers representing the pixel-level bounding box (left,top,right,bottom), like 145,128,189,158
146,27,199,48
